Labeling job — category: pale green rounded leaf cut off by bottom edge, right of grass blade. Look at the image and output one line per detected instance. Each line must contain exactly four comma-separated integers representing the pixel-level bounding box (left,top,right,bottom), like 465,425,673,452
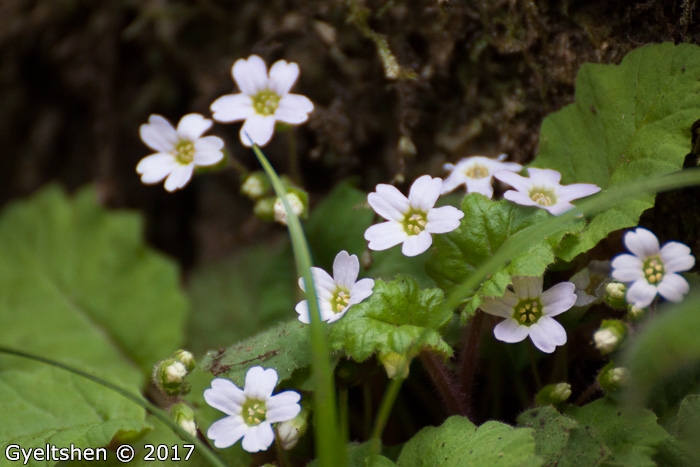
396,416,542,467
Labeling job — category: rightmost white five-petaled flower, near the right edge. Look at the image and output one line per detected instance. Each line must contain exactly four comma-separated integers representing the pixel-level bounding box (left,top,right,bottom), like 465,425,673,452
612,227,695,308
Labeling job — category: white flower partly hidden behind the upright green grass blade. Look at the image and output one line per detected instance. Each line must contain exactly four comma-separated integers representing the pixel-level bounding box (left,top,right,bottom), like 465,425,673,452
295,250,374,324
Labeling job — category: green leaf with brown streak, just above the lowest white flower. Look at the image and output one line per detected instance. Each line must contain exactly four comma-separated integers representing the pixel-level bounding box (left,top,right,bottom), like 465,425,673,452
201,319,316,390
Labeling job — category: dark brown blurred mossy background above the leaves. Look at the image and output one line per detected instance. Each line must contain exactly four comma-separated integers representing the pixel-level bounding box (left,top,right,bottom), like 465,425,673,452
0,0,700,268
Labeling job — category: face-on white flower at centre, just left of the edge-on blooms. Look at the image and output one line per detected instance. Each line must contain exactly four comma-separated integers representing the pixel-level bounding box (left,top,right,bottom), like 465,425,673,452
365,175,464,256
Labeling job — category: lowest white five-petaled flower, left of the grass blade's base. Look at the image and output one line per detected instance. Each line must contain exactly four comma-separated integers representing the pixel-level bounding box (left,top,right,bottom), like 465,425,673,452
204,366,301,452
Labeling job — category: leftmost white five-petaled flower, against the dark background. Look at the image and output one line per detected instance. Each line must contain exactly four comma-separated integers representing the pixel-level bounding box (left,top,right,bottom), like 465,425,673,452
136,114,224,192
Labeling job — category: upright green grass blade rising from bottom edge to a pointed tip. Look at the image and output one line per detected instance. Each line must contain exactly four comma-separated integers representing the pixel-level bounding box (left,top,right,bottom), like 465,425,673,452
253,145,347,467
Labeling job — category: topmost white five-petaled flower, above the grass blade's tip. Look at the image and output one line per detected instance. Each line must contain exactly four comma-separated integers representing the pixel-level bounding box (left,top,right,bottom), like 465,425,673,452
211,55,314,147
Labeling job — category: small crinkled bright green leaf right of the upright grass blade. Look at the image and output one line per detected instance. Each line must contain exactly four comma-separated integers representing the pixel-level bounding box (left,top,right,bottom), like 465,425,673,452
329,276,452,362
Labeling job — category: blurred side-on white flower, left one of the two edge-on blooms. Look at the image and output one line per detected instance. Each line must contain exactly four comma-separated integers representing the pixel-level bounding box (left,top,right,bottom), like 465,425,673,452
442,154,523,198
